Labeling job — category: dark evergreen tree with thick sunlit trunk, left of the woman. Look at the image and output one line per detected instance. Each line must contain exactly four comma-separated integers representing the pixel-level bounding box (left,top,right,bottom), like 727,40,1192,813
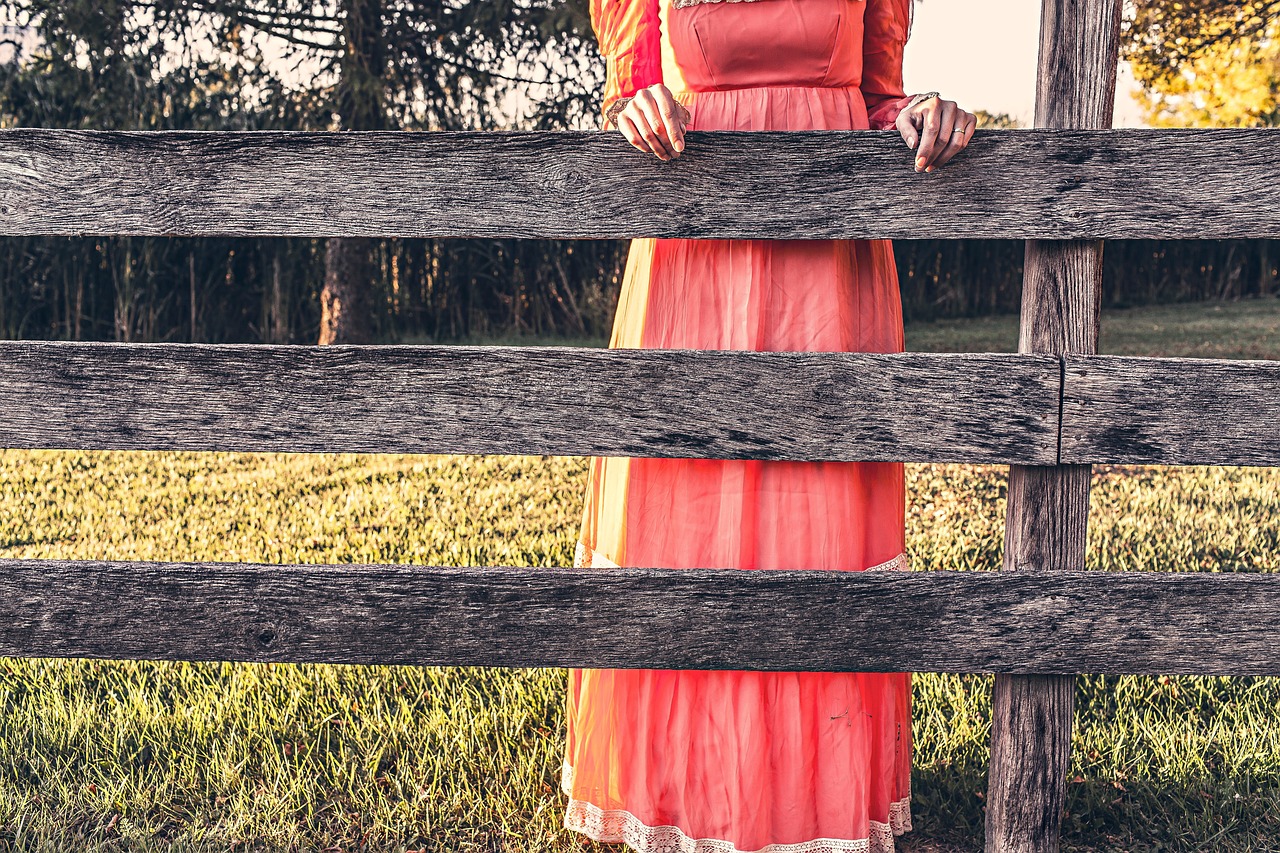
138,0,589,343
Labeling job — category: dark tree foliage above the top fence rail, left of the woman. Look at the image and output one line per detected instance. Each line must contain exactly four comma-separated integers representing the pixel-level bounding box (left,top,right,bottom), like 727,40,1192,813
0,0,598,129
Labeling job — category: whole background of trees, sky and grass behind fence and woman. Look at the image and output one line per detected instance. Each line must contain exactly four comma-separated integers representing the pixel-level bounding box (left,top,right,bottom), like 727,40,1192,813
0,0,1280,853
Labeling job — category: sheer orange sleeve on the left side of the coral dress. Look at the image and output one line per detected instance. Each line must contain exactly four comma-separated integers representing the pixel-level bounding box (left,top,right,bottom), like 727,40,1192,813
591,0,662,127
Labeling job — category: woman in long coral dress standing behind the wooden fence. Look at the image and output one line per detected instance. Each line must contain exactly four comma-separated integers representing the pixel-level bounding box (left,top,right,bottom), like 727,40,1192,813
562,0,975,853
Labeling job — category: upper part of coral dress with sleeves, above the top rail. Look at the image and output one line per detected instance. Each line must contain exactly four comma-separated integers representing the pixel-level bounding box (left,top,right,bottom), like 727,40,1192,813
591,0,911,129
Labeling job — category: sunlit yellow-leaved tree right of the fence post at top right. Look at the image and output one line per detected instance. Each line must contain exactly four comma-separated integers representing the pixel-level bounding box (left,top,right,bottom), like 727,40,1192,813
1124,0,1280,127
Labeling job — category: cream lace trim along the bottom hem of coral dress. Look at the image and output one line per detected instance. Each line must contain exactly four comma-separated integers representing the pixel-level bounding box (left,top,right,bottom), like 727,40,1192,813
561,761,911,853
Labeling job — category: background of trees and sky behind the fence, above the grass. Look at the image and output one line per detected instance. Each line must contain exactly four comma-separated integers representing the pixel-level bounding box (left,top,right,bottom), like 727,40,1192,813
0,0,1280,343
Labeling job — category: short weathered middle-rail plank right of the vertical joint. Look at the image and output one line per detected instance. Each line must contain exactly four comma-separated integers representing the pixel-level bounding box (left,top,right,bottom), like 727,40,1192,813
1062,356,1280,465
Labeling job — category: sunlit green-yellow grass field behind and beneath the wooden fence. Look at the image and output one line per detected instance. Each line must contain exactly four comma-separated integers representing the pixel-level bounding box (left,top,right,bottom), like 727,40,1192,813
0,300,1280,850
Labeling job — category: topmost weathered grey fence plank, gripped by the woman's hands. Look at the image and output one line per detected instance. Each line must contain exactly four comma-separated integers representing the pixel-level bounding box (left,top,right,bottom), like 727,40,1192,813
0,128,1280,240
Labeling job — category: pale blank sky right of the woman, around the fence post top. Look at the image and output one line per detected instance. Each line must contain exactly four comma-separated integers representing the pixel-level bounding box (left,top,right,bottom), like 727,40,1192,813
902,0,1144,127
